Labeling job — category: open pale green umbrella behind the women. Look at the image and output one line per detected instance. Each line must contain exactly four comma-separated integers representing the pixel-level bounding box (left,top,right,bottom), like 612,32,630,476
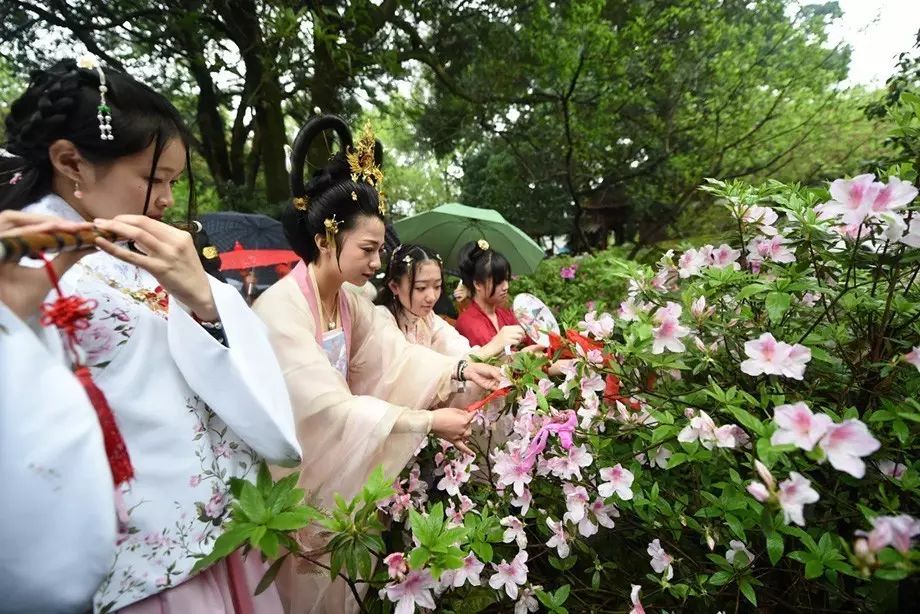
393,203,543,275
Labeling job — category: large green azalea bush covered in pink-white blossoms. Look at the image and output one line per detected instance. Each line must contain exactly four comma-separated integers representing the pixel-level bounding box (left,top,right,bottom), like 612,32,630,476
205,100,920,614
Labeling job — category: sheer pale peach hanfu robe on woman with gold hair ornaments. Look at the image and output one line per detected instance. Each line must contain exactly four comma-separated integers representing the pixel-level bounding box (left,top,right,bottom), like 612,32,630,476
253,263,474,614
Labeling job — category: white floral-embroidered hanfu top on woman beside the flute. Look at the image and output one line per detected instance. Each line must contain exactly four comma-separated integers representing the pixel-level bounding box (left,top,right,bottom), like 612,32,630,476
25,195,300,612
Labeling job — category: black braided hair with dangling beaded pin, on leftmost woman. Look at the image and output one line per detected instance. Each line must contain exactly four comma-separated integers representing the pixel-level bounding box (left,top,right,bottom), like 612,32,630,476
0,59,195,215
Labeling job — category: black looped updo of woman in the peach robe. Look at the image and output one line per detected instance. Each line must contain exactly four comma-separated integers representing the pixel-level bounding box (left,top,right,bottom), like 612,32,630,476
281,115,384,262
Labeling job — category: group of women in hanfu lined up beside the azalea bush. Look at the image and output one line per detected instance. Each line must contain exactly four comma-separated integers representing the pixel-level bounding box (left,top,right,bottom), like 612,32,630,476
0,58,548,614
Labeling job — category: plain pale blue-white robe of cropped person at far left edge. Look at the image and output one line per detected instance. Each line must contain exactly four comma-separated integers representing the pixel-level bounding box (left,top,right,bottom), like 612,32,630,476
0,303,115,614
